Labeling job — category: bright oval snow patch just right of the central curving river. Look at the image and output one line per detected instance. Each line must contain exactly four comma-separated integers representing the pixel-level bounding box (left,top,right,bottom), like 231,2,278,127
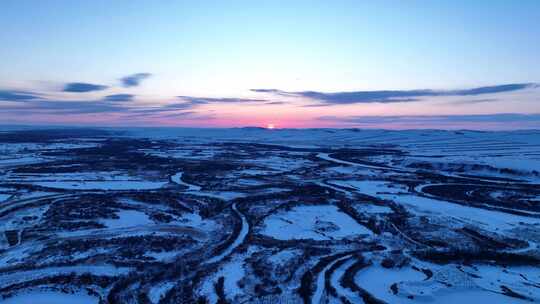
261,205,372,240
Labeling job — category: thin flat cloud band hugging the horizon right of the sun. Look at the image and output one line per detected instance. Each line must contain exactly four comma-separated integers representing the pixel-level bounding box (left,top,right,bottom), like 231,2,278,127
318,113,540,126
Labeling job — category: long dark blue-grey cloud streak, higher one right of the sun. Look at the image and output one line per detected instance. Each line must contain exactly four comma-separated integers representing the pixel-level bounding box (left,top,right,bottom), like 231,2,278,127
251,83,538,106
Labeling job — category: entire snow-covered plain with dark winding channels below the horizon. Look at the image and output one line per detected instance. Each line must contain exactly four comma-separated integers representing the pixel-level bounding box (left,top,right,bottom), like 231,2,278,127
0,128,540,304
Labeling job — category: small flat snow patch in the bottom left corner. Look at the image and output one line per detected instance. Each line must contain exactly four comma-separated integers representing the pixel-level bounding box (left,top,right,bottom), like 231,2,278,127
0,291,99,304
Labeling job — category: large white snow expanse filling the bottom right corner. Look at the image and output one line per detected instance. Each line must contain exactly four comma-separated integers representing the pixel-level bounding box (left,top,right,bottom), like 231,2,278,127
364,257,540,304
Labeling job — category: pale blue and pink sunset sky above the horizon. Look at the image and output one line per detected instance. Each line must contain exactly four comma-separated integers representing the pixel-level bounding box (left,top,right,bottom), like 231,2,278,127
0,0,540,130
